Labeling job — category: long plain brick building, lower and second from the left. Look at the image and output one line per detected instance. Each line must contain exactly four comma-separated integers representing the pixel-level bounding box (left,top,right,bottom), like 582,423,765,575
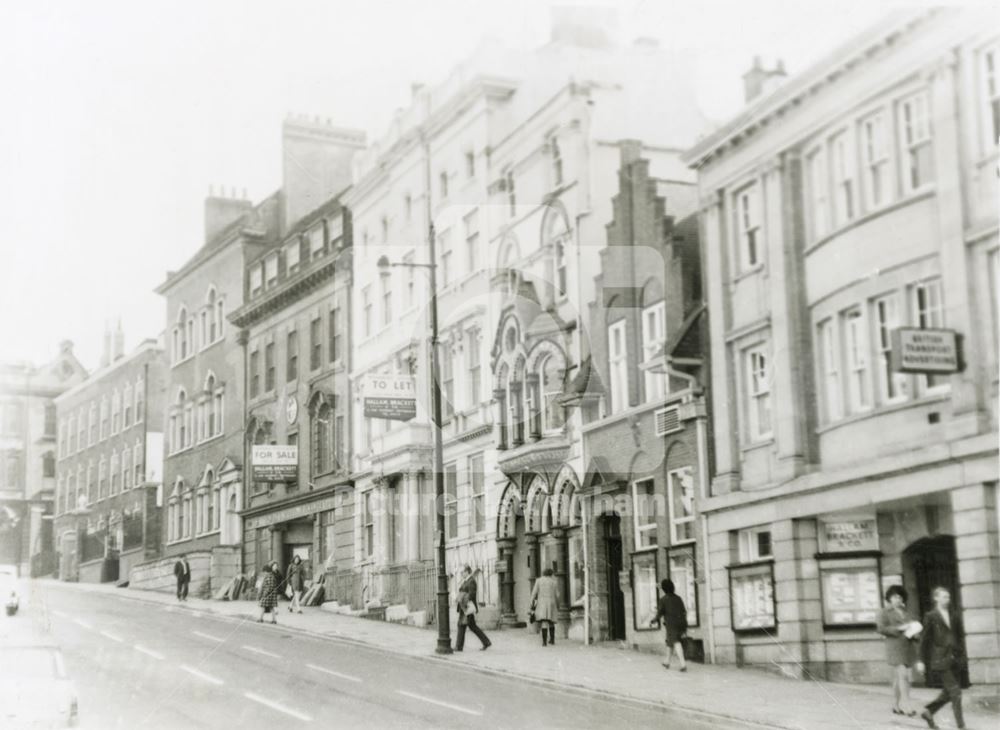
55,332,167,583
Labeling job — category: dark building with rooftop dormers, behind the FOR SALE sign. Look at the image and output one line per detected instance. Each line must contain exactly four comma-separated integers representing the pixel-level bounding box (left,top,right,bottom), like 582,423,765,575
230,192,354,584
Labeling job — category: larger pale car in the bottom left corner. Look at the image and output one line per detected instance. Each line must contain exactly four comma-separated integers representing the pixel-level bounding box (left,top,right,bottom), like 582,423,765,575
0,642,79,729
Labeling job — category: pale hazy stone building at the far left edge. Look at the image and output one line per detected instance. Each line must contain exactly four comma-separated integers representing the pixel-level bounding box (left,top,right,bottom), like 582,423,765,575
0,341,87,576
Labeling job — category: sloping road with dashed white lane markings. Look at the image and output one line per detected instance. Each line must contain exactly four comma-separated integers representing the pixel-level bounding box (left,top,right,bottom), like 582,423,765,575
18,583,752,730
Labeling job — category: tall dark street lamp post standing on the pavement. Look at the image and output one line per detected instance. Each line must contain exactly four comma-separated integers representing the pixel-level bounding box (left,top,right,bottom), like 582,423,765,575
378,247,451,654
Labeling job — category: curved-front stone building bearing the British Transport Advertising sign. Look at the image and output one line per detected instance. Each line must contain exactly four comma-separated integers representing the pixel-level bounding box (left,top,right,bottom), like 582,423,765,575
686,9,1000,683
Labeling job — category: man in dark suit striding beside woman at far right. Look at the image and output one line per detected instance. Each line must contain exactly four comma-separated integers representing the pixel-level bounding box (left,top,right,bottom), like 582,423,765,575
917,586,965,728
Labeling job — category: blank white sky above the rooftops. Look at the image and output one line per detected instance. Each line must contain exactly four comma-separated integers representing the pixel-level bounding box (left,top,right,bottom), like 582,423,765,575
0,0,956,368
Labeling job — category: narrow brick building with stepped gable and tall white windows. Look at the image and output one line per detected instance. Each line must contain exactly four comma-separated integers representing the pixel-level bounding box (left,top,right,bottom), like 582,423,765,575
565,142,710,657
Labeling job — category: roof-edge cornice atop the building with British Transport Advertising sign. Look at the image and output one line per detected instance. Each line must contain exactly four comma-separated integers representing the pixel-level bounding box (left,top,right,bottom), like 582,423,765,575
681,7,942,167
